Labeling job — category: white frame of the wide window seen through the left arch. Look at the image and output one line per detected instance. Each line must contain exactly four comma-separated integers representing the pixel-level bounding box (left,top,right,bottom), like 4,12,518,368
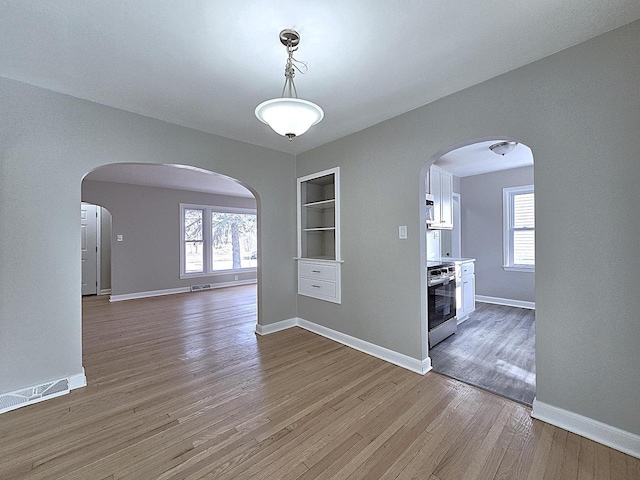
180,203,258,279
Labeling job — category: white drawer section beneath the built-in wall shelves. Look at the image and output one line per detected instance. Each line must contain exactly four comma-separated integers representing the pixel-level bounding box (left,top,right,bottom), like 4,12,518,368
298,259,341,303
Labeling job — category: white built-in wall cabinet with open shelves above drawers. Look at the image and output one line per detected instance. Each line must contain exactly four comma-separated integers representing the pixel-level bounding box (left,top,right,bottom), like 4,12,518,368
297,167,342,303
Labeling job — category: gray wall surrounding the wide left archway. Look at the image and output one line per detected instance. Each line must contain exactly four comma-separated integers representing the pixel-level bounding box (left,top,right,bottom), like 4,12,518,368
0,79,296,392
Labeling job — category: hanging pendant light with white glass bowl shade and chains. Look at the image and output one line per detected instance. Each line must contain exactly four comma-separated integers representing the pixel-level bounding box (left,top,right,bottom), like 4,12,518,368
256,29,324,141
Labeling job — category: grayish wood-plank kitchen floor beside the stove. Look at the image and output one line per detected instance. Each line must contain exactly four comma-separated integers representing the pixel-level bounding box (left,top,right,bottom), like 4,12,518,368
429,303,536,405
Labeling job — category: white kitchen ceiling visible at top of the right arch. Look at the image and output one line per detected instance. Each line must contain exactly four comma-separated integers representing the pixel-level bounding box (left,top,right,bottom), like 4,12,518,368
435,140,533,177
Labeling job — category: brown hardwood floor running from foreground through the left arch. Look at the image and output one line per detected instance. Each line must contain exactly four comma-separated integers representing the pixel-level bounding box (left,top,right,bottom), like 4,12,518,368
0,286,640,480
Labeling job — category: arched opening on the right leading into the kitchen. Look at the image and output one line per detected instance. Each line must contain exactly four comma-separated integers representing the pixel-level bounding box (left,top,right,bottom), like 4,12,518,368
420,137,535,405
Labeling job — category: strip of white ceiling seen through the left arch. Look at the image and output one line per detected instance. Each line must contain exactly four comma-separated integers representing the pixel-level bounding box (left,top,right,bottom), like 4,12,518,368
84,163,254,198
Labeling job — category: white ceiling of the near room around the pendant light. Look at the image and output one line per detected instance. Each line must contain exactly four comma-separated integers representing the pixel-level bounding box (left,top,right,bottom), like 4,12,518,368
0,0,640,154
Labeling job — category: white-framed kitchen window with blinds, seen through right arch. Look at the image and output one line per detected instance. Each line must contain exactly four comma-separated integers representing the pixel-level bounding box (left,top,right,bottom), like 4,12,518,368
502,185,536,272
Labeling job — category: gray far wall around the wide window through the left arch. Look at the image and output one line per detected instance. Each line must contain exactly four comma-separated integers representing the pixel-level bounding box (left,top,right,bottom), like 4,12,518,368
82,180,256,295
